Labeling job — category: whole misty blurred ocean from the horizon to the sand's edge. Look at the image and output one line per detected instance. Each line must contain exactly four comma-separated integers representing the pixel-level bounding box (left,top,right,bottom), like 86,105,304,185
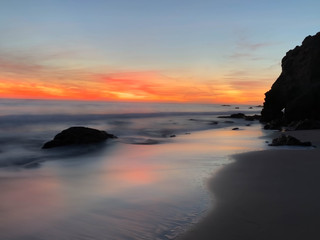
0,99,265,240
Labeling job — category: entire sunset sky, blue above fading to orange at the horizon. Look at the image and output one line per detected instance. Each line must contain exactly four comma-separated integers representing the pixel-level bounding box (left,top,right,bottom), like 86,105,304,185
0,0,320,104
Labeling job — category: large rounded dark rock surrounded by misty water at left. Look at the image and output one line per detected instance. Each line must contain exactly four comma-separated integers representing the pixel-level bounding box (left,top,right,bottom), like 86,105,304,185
42,127,117,148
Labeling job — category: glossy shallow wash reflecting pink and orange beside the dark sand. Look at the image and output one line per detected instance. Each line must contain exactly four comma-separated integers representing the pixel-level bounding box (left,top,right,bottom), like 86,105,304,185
0,126,263,240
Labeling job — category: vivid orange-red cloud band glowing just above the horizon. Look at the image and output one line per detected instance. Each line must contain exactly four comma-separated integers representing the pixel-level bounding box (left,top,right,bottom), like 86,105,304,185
0,72,266,103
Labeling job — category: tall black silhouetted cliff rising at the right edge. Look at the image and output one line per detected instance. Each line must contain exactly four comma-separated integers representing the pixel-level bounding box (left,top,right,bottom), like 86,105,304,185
261,32,320,123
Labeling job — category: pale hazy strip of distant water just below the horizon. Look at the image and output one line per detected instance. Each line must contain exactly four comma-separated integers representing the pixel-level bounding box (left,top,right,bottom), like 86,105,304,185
0,99,257,116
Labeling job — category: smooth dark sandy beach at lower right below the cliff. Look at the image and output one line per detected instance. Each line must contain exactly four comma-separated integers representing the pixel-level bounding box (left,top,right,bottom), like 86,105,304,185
180,130,320,240
